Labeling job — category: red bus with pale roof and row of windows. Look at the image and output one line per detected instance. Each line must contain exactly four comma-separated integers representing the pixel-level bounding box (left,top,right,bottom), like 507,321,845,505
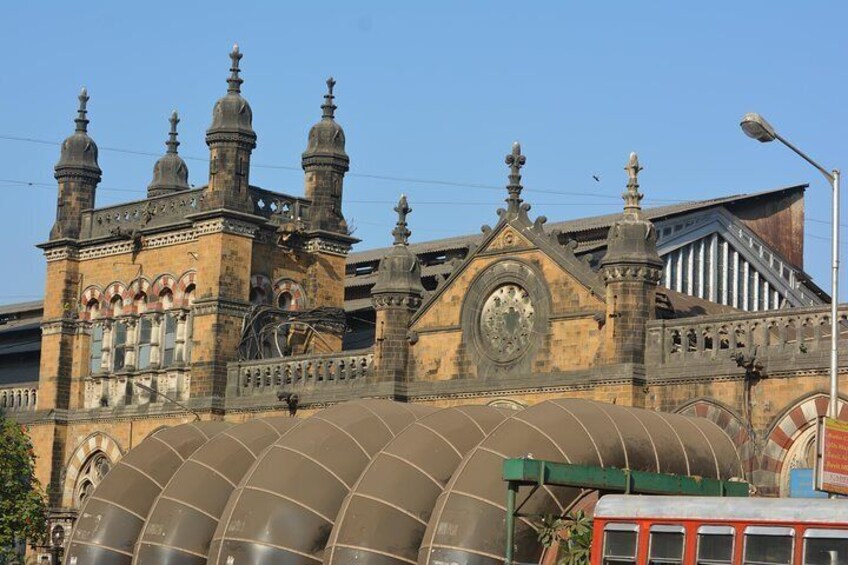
591,495,848,565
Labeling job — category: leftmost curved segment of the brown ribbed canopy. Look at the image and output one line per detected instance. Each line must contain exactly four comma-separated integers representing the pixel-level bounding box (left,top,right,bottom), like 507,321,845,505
65,422,230,565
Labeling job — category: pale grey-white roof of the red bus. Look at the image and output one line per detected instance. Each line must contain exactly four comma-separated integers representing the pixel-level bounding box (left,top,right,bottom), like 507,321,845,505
595,495,848,527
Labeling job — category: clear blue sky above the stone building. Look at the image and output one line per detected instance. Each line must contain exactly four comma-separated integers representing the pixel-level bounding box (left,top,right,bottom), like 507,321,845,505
0,0,848,303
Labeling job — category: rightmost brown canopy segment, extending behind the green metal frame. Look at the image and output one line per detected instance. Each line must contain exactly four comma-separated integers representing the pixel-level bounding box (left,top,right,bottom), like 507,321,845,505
418,399,742,565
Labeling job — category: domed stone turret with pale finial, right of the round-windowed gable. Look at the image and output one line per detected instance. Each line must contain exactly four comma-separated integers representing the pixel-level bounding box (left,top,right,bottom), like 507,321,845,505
600,153,663,363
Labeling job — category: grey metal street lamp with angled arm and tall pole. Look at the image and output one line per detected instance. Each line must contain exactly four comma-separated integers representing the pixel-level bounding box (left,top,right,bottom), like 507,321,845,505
739,112,839,418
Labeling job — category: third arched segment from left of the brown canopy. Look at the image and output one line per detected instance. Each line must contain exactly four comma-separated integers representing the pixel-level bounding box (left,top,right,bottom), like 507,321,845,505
209,400,434,565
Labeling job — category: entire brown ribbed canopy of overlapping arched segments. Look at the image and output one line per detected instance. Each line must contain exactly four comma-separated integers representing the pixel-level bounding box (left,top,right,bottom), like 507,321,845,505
66,399,742,565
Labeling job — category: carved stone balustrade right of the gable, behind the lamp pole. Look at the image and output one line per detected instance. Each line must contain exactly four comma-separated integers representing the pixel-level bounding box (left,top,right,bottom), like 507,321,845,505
646,306,848,365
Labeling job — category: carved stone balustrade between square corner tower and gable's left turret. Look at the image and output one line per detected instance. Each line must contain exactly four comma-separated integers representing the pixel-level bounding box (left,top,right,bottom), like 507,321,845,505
234,349,374,396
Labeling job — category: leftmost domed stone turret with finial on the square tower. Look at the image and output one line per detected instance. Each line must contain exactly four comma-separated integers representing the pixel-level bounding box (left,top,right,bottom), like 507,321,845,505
50,88,101,240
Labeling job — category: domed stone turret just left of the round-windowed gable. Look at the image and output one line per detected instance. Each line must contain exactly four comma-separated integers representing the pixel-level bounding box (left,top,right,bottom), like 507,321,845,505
371,195,424,382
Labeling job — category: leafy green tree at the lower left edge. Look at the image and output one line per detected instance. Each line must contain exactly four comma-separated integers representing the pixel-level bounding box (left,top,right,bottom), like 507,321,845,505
0,414,47,564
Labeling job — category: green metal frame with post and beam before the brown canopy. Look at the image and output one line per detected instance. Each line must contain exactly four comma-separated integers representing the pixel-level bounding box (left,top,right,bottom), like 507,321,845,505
503,458,748,565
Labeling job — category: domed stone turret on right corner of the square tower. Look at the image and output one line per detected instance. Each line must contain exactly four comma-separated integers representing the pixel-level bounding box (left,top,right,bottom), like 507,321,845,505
301,77,350,235
